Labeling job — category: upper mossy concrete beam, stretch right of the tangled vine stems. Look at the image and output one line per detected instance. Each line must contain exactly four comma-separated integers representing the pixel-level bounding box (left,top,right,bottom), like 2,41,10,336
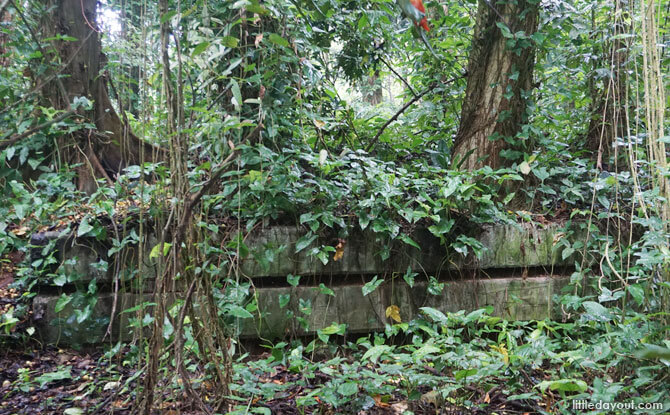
242,224,574,277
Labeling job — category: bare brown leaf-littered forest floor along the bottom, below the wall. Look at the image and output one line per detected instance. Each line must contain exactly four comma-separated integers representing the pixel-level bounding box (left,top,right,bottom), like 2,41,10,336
0,348,532,415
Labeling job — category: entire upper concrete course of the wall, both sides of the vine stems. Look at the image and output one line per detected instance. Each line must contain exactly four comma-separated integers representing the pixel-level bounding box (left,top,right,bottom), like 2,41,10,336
31,224,574,291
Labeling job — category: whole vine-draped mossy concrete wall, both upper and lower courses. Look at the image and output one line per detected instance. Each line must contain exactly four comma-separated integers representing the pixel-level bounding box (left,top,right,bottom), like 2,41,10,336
33,224,574,344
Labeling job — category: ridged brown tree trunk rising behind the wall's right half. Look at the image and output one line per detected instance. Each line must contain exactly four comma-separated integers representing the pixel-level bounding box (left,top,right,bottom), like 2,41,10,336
453,0,538,170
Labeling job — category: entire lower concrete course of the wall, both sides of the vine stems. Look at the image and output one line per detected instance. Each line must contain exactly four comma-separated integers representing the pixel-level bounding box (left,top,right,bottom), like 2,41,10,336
33,276,569,344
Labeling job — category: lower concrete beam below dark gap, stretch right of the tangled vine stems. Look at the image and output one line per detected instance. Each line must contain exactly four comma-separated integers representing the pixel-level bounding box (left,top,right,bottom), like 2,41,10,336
241,276,569,338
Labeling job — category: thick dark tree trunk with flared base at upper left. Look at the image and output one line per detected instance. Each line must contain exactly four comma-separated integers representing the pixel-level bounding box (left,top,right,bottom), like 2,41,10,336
41,0,163,193
